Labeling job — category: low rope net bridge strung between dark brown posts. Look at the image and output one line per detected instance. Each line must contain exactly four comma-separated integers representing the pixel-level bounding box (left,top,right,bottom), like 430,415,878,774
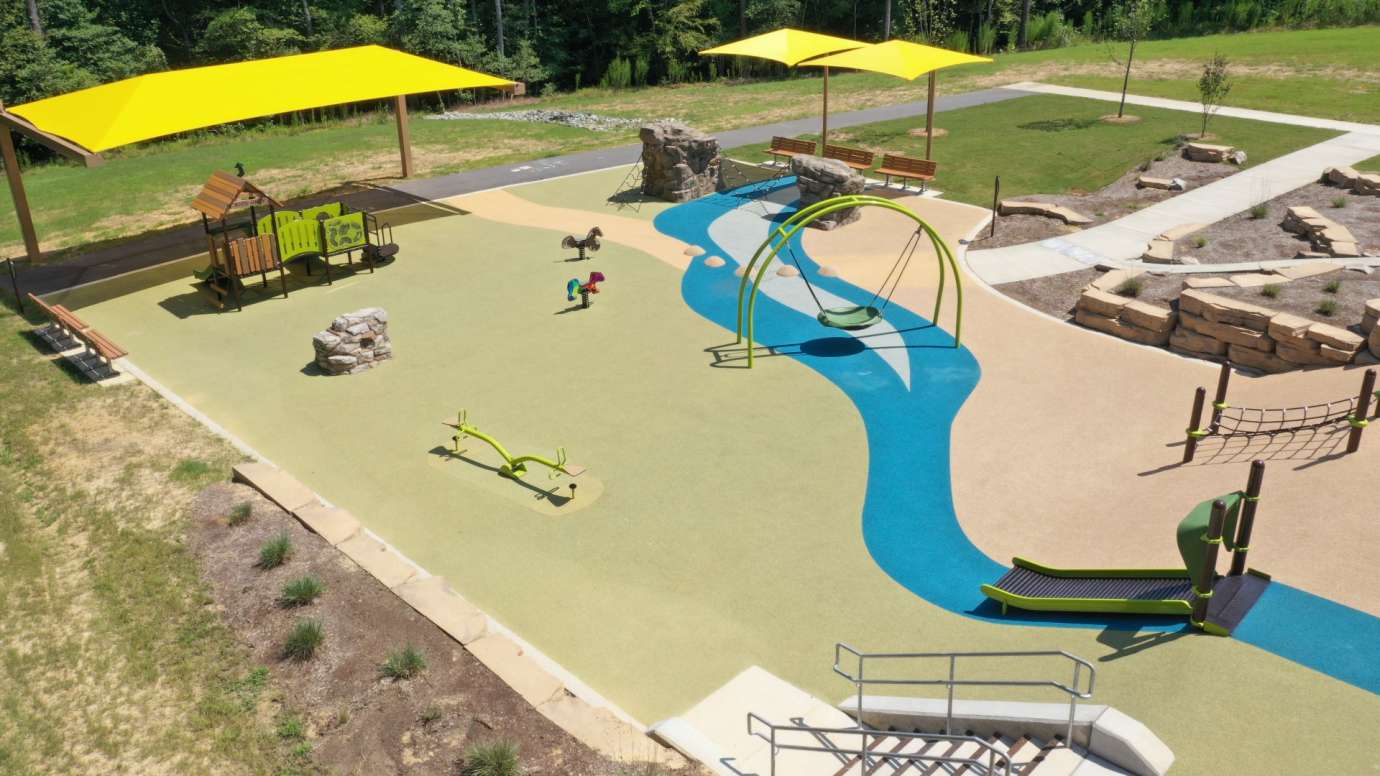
1183,362,1380,464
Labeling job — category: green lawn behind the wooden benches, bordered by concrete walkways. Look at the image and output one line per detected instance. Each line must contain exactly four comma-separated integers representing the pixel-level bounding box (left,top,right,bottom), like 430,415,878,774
729,95,1336,206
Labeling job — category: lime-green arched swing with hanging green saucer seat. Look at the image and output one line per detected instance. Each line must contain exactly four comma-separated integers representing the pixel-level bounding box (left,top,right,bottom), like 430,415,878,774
734,195,963,369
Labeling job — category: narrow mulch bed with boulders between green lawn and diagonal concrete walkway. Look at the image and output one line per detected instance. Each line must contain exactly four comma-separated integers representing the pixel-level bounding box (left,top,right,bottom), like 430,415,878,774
970,149,1241,250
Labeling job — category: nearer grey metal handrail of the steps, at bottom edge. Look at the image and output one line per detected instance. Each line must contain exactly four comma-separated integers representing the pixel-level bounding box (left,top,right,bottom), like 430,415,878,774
748,711,1012,776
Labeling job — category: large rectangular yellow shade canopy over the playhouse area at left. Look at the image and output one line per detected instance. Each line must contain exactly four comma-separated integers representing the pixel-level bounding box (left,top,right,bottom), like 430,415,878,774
8,46,513,152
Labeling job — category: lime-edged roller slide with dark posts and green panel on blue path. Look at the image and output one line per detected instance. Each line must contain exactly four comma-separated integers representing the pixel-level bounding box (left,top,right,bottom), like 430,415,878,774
981,461,1270,637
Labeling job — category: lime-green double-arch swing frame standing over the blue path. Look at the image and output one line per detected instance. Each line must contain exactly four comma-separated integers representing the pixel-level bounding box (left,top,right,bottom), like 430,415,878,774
734,195,963,369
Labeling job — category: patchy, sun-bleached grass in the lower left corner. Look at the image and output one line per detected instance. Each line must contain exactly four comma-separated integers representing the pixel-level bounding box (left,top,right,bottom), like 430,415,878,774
0,308,305,775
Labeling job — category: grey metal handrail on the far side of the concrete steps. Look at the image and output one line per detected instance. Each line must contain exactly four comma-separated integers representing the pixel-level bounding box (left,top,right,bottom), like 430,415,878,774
834,642,1097,747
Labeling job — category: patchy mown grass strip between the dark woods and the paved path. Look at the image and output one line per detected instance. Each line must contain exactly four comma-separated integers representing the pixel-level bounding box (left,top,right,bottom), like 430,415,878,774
0,26,1380,255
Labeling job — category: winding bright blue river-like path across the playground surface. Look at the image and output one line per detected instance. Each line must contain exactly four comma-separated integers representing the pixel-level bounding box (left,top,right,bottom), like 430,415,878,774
656,178,1380,693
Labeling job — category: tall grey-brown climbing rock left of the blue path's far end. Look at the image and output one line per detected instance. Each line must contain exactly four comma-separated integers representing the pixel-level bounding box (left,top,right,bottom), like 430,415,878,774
638,122,720,202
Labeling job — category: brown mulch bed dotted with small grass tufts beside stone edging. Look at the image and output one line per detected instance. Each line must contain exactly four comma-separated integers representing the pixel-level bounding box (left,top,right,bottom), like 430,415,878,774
188,485,673,776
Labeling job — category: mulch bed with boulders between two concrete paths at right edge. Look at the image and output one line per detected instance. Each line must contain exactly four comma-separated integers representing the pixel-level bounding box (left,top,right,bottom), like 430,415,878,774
1174,180,1380,264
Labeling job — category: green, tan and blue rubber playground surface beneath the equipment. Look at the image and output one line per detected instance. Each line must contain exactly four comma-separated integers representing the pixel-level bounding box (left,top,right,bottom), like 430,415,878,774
66,164,1380,773
